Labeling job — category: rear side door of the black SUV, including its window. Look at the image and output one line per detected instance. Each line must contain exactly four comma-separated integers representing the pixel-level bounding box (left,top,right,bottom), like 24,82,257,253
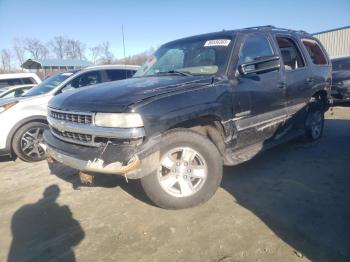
276,34,313,115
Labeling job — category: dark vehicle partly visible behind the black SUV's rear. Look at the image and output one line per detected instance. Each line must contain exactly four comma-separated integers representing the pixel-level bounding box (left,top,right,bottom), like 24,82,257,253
331,56,350,102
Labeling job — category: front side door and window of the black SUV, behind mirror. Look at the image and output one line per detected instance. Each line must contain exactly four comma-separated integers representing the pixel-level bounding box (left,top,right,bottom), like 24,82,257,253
233,32,286,148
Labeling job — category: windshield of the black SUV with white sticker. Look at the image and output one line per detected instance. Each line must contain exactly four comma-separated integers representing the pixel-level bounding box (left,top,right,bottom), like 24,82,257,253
134,37,233,77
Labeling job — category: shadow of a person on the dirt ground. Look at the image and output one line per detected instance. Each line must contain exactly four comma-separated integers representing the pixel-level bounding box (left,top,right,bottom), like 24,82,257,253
8,185,85,262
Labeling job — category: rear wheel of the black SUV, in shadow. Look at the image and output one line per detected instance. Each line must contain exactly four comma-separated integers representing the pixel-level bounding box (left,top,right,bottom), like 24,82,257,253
305,102,324,141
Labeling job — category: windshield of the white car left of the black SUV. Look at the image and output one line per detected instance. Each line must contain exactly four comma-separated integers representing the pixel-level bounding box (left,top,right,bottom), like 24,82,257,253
24,72,73,96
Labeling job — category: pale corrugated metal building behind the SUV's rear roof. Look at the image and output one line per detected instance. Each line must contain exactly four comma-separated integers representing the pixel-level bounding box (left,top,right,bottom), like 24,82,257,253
313,26,350,58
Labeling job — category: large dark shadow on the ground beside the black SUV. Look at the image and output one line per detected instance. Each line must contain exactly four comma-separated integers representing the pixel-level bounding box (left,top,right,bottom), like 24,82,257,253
222,120,350,261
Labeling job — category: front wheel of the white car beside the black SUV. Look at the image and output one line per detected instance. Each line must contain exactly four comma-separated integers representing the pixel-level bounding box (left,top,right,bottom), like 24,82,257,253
12,122,48,162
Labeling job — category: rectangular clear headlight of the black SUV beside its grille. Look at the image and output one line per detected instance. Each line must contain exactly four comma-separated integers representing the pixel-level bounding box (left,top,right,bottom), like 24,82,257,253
95,113,143,128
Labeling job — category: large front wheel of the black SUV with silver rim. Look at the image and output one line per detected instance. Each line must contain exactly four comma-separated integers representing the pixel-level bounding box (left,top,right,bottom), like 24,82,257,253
141,129,223,209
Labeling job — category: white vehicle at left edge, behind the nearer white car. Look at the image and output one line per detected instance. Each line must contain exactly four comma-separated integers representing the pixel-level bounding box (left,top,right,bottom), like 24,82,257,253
0,73,41,88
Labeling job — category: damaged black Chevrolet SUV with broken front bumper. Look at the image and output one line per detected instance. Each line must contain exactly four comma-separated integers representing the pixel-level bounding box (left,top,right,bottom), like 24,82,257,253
45,26,331,209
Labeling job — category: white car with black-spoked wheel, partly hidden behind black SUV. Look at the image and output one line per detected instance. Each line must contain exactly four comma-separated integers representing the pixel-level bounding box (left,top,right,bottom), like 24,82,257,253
0,65,139,162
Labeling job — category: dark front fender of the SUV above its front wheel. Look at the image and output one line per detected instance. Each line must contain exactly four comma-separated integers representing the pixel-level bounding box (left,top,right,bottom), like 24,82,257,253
135,83,232,136
